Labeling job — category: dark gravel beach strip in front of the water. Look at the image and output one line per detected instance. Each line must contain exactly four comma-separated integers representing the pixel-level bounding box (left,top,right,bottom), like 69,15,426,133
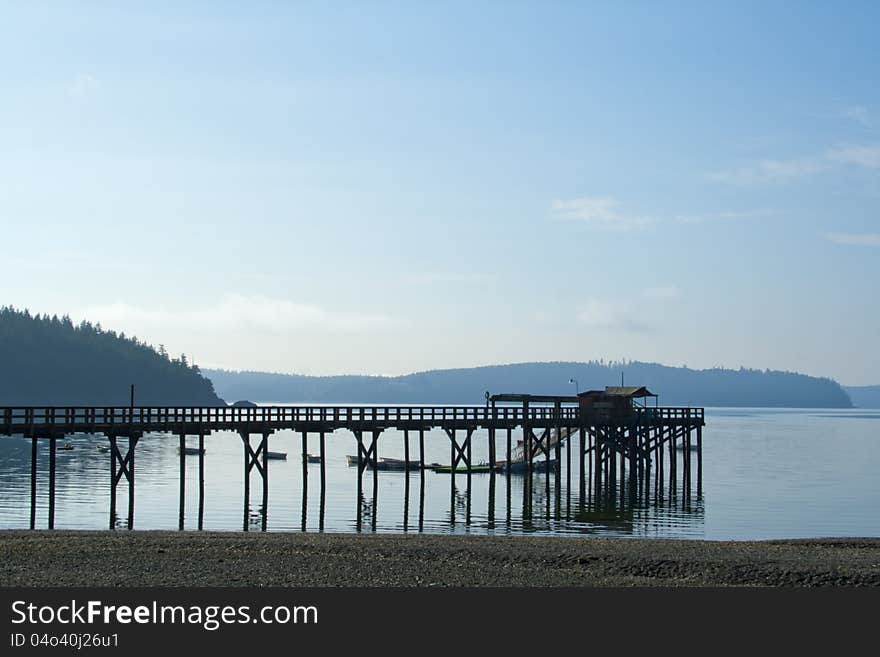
0,531,880,587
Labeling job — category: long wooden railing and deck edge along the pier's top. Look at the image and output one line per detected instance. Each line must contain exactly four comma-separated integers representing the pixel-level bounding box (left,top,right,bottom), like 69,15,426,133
0,406,704,434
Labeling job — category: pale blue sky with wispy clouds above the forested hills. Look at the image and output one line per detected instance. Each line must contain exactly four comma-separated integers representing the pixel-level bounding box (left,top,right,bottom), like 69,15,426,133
0,2,880,384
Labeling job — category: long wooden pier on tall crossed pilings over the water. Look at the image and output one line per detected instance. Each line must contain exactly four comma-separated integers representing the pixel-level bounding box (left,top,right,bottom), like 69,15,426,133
0,395,705,530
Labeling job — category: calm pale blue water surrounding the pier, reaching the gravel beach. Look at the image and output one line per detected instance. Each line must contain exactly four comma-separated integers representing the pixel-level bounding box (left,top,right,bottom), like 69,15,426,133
0,409,880,539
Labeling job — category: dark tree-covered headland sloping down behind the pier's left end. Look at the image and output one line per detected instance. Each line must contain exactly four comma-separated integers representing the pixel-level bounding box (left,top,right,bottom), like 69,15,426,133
0,307,225,406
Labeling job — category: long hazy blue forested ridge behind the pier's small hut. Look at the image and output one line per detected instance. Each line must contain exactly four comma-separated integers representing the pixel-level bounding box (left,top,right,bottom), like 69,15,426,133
205,361,852,408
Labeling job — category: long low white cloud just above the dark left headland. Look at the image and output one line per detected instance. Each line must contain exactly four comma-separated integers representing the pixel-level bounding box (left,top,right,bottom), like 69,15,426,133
79,295,400,334
